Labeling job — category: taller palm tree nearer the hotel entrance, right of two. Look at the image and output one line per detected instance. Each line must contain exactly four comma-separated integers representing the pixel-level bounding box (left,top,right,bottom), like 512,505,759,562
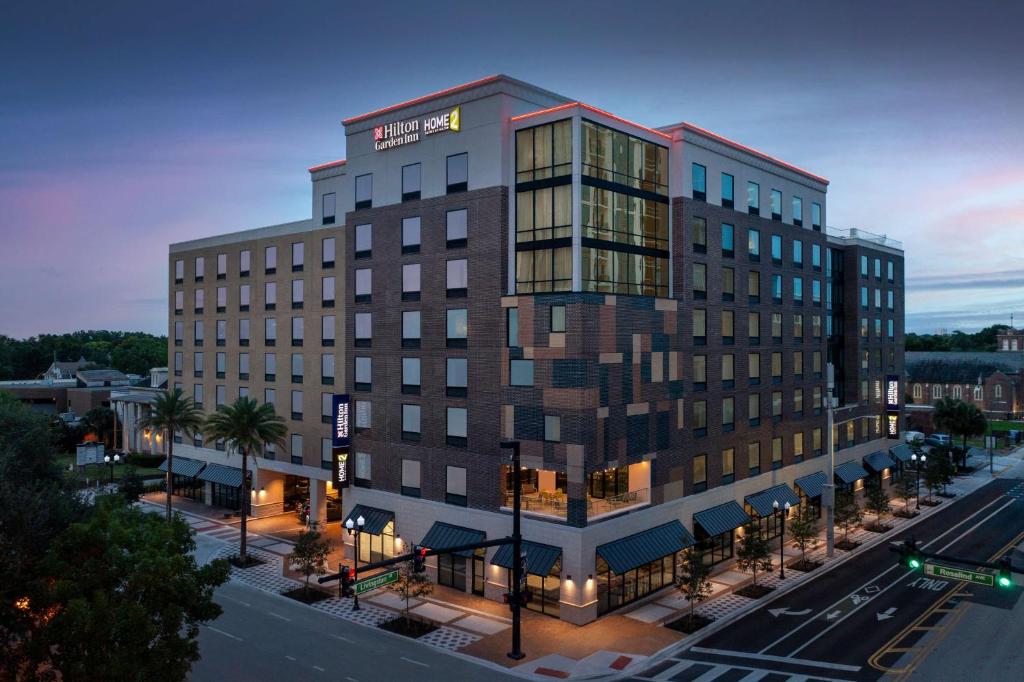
203,396,288,567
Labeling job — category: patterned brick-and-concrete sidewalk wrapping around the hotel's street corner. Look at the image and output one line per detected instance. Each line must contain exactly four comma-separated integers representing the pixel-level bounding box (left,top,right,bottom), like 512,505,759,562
142,454,1024,679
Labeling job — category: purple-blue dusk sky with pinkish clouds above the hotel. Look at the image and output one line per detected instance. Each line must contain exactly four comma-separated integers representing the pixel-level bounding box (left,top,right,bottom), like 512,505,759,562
0,0,1024,337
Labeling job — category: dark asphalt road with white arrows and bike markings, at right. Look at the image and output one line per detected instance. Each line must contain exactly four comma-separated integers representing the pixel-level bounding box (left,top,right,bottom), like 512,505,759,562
634,479,1024,682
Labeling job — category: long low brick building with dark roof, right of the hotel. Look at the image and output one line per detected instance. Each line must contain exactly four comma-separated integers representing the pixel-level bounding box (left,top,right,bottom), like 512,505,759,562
906,352,1024,419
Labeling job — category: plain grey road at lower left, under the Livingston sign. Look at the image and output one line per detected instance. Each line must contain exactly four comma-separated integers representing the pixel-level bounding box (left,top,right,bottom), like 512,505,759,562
189,538,512,682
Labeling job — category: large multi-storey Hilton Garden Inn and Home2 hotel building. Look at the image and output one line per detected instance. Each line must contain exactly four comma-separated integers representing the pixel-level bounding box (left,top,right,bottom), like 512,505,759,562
168,76,903,624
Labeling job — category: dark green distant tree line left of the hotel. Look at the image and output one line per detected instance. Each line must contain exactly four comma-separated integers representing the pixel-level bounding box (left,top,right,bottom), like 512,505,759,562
0,330,167,381
